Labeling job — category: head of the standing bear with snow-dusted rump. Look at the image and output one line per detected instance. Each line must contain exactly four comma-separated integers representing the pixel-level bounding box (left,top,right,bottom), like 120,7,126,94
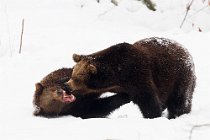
66,54,118,95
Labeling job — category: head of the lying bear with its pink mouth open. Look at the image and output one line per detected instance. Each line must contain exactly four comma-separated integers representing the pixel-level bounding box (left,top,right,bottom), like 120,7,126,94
33,83,76,116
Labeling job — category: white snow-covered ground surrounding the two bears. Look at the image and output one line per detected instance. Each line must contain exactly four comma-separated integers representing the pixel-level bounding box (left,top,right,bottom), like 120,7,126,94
0,0,210,140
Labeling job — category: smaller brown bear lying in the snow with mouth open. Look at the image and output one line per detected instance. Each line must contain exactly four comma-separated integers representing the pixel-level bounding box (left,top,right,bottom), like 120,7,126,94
33,68,130,118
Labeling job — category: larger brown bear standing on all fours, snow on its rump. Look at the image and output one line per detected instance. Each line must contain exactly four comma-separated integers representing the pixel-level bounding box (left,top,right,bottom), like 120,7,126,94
66,37,196,118
